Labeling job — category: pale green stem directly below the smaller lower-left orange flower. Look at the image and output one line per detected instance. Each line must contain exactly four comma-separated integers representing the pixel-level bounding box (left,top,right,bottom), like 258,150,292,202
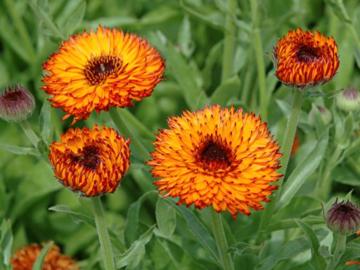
91,197,115,270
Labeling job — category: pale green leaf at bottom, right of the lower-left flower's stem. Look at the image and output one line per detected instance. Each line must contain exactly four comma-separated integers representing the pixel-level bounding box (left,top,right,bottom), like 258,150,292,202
115,225,155,270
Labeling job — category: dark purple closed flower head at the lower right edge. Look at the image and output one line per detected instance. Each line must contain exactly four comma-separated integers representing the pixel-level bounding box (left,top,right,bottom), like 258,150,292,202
326,201,360,234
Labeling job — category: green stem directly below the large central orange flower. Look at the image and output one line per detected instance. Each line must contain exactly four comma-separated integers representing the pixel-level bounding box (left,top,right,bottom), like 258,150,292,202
211,211,235,270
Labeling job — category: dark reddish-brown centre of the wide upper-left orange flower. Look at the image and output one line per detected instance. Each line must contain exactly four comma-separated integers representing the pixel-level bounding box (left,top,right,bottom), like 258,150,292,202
84,56,121,85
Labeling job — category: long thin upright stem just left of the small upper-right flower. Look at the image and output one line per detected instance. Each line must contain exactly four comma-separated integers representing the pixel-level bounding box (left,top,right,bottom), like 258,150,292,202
250,0,268,120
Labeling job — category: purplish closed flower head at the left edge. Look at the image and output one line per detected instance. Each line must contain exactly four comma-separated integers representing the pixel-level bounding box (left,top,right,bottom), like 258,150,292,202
0,85,35,122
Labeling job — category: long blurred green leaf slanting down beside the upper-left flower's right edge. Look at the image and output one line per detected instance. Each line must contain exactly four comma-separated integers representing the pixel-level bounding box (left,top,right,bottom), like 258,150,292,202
150,32,208,110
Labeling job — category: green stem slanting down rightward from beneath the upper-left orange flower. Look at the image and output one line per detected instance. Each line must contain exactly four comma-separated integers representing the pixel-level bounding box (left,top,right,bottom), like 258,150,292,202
109,109,150,161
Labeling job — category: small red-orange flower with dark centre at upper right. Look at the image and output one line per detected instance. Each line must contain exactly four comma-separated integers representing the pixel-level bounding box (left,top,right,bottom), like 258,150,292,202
274,28,339,87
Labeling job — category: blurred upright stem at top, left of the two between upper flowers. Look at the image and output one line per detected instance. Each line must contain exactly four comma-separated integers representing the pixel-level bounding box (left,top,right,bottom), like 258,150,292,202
221,0,236,82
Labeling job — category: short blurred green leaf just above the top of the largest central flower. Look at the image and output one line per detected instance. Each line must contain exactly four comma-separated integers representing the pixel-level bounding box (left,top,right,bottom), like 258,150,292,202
211,76,240,106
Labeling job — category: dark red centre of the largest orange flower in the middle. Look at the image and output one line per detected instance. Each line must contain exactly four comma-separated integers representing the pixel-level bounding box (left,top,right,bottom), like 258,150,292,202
199,140,231,169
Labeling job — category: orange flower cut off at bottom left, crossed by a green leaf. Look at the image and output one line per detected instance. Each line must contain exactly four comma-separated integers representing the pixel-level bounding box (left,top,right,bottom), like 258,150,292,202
11,244,80,270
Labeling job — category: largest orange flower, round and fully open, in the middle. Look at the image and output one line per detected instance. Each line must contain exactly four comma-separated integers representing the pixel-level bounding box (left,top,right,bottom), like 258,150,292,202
149,105,281,218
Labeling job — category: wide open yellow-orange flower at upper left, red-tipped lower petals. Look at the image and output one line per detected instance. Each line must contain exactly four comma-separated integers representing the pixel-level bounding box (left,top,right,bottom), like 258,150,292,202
43,26,164,122
